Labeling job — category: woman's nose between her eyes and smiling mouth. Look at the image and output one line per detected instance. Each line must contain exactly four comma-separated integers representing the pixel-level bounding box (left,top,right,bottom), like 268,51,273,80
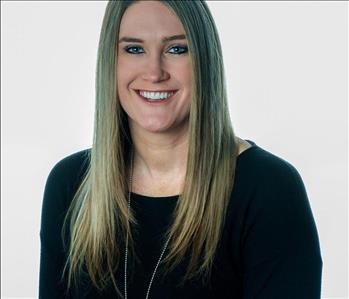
142,54,169,82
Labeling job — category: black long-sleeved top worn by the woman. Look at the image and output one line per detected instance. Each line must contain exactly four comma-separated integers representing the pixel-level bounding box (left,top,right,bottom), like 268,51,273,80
39,140,323,299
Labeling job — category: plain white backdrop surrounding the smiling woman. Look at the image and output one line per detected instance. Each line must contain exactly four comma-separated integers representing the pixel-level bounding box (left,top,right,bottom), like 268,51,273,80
1,1,348,298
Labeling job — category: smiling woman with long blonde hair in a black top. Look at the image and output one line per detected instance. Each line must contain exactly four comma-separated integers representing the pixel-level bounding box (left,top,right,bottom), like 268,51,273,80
39,1,322,299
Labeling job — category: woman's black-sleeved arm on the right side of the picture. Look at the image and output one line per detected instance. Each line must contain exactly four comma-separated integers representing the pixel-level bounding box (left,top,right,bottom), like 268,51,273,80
242,164,322,299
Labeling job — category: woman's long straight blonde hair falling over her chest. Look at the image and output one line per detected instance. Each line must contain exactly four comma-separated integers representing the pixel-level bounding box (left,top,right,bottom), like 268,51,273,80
62,1,238,297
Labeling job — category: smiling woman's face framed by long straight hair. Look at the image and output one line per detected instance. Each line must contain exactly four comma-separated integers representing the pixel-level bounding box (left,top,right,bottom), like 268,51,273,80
117,1,192,132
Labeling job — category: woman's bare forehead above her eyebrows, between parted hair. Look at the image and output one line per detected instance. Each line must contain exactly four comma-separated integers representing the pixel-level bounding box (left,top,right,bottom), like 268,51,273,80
119,1,185,39
